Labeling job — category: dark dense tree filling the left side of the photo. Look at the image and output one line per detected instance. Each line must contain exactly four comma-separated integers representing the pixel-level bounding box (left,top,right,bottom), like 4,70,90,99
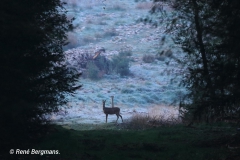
0,0,79,149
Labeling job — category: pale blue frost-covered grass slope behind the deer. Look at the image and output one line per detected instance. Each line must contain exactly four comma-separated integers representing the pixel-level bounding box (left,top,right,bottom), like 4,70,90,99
57,0,185,122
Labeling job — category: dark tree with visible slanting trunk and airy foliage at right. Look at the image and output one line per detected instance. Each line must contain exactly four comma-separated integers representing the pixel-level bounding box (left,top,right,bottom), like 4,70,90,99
147,0,240,121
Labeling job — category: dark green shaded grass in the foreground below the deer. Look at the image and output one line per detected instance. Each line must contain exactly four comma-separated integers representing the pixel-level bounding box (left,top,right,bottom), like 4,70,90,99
7,123,239,160
